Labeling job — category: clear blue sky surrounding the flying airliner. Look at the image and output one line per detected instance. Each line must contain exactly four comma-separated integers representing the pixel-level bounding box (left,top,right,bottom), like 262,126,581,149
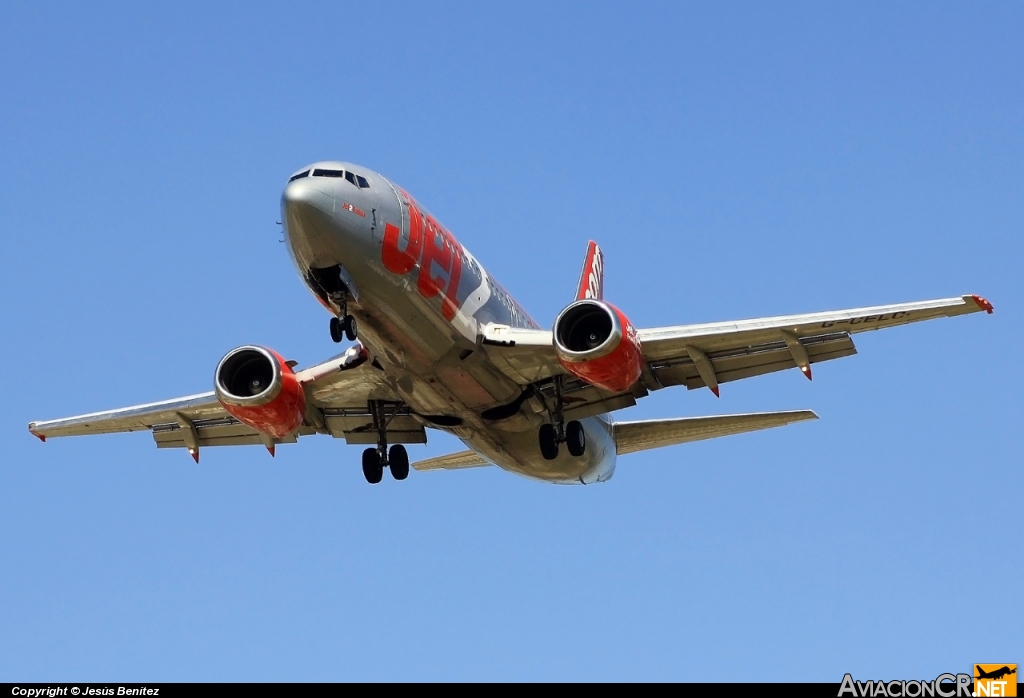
0,2,1024,682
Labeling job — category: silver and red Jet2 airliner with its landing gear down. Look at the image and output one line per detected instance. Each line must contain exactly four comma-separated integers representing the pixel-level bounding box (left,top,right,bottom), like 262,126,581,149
29,161,992,484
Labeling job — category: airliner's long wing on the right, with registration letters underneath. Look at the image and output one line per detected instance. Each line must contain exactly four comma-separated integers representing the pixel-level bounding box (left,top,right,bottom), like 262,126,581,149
482,296,992,397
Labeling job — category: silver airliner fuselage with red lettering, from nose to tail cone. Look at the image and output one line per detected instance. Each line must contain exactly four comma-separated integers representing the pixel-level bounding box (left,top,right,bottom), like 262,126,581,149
282,162,615,484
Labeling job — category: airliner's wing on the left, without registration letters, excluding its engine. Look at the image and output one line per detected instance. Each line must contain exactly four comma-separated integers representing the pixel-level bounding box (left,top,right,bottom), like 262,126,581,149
29,345,411,456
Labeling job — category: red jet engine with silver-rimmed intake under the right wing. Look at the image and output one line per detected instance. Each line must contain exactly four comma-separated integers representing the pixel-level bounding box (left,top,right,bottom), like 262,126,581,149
554,299,643,393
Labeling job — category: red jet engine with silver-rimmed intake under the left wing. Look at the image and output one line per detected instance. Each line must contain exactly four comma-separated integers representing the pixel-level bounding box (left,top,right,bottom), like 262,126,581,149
213,347,306,439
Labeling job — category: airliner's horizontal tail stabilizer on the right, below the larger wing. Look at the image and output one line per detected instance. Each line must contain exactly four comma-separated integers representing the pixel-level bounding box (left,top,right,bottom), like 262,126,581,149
614,409,818,455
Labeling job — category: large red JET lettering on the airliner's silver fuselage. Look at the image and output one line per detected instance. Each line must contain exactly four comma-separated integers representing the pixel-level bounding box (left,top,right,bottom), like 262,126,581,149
381,192,462,321
